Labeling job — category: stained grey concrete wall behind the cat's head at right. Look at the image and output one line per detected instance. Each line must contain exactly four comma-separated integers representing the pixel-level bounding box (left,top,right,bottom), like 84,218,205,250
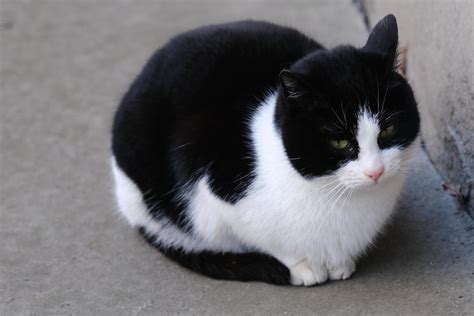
363,0,474,215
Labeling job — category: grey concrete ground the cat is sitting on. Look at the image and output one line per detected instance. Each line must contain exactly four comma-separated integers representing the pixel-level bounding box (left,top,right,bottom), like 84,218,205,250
0,0,474,315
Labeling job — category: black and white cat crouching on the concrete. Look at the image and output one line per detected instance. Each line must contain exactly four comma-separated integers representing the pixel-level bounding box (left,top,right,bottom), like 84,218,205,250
112,15,420,286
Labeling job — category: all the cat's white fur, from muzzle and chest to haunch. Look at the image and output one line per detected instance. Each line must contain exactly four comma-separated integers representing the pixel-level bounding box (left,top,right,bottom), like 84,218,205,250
112,95,418,285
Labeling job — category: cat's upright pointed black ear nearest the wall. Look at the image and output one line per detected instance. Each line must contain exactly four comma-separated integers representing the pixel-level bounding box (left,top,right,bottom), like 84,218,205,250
363,14,398,61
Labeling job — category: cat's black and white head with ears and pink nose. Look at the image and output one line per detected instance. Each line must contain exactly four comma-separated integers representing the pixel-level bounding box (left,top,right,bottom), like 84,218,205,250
275,15,420,187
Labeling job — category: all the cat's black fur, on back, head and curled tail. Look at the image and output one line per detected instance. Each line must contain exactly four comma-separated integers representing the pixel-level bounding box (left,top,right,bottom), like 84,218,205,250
112,16,419,284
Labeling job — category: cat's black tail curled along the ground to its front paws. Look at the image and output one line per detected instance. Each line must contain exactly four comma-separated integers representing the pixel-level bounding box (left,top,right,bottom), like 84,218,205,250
139,228,291,285
